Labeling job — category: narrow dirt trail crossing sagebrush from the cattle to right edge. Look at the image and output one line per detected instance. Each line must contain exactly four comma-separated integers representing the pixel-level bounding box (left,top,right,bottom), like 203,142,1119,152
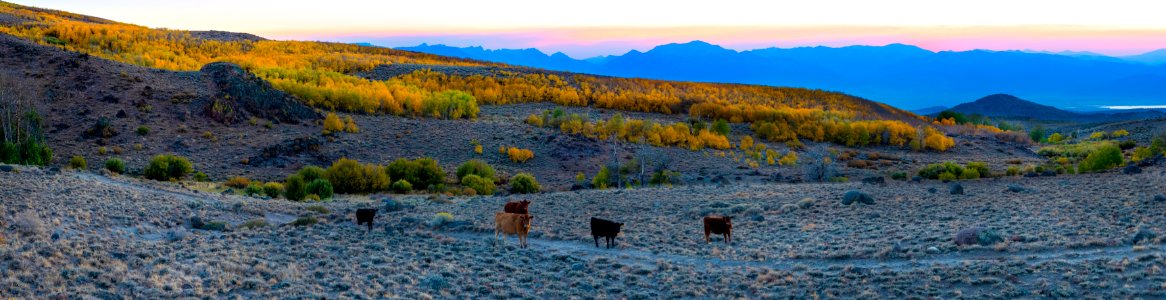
443,232,1163,272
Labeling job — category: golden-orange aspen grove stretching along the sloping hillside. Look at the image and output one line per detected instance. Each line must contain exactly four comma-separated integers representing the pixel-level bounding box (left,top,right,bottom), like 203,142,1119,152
0,4,954,151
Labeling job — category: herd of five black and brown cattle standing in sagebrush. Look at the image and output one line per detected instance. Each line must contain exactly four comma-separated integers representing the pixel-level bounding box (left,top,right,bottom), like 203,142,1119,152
357,200,732,249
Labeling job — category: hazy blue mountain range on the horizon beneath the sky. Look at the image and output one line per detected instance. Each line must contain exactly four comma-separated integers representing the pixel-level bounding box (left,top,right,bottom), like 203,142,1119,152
396,41,1166,109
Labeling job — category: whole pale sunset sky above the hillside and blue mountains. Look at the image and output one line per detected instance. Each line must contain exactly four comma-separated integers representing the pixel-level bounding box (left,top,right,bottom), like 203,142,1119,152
14,0,1166,58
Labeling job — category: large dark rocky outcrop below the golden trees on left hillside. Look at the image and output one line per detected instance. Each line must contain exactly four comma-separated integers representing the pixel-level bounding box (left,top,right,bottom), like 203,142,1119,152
201,63,321,124
